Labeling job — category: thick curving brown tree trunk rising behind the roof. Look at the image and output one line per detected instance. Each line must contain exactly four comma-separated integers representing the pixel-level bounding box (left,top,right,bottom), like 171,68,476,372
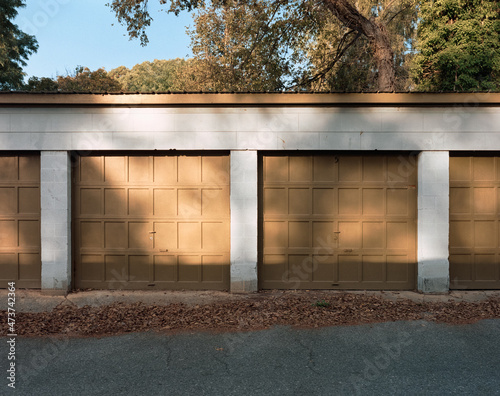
320,0,396,92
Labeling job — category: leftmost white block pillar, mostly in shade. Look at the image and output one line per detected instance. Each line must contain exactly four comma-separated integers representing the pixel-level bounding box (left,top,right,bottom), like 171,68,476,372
40,151,71,294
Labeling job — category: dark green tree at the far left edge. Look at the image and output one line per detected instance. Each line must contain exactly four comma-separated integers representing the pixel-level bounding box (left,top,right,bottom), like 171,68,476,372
0,0,38,90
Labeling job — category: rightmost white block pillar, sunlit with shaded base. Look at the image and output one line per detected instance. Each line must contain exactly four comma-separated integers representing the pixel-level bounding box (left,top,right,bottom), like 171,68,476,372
417,151,450,293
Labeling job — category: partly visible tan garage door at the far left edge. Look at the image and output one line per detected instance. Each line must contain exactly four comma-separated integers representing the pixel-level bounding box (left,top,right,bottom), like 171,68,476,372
0,154,41,288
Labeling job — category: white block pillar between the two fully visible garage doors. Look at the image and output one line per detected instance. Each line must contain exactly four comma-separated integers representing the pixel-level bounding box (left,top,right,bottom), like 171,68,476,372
231,151,258,293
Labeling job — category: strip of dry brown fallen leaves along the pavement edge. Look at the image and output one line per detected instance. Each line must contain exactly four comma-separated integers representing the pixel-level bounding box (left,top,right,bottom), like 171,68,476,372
0,291,500,337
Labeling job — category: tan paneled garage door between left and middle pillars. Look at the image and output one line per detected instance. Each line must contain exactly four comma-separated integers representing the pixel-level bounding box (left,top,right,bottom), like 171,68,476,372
73,155,230,290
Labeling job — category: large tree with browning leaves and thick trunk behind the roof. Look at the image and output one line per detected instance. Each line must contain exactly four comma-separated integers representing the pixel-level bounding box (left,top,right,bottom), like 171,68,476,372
109,0,415,91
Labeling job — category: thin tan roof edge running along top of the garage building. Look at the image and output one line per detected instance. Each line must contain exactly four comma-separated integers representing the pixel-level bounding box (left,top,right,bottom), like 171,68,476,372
0,92,500,107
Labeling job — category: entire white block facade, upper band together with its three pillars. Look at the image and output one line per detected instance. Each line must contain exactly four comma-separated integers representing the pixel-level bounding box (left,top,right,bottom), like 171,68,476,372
0,106,500,293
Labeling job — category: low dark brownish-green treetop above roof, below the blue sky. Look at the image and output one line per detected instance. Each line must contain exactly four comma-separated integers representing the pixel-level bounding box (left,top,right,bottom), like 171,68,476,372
57,66,122,92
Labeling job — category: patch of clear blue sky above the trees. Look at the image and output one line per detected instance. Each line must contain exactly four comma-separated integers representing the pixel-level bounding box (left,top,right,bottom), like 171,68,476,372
15,0,192,78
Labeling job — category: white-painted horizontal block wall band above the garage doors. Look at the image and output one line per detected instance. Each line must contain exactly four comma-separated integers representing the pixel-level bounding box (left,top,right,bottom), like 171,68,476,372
0,107,500,152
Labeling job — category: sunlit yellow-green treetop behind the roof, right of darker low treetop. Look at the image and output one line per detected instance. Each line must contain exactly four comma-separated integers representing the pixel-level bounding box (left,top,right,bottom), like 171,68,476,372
108,58,186,92
